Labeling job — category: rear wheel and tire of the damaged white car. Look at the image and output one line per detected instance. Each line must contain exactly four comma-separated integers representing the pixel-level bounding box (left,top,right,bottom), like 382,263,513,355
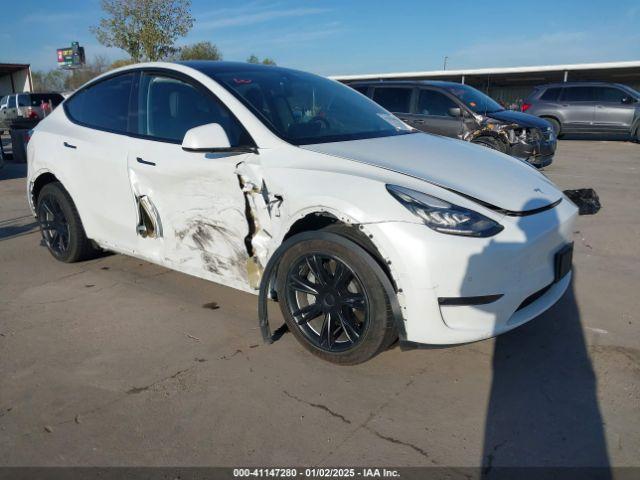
36,182,98,263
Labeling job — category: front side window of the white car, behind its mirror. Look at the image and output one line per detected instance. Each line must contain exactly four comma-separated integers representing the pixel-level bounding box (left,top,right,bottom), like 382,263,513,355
137,74,251,147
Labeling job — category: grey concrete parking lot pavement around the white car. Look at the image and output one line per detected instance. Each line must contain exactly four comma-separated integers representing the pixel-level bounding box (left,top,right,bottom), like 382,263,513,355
0,140,640,470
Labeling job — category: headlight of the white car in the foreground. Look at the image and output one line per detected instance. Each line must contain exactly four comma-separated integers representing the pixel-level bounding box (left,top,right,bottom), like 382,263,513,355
387,185,504,237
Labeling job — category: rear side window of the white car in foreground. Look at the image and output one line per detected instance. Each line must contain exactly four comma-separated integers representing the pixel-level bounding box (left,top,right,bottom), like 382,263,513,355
65,73,134,133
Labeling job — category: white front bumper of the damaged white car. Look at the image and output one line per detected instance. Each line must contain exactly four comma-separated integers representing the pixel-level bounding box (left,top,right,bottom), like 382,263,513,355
368,200,577,344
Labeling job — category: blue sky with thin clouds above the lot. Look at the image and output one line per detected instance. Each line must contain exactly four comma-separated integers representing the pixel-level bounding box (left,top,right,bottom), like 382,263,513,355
0,0,640,75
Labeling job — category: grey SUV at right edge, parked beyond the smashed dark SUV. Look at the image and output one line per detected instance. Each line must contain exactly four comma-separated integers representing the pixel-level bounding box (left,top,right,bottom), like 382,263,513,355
522,82,640,141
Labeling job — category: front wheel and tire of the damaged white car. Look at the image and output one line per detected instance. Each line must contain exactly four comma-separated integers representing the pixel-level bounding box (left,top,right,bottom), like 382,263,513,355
276,232,395,365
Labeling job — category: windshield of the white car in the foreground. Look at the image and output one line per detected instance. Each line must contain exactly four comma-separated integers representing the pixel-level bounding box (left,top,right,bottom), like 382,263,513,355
212,67,414,145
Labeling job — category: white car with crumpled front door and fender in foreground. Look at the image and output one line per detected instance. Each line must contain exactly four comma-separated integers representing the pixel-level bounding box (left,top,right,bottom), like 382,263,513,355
28,62,577,364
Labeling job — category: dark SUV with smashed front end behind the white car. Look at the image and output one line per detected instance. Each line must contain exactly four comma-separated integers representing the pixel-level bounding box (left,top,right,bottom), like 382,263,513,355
349,81,556,168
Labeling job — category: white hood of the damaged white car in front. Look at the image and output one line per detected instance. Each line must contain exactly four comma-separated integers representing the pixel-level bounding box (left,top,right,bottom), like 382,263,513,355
301,133,562,212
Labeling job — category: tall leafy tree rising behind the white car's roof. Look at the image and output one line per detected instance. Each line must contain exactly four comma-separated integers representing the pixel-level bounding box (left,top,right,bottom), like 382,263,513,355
91,0,193,62
